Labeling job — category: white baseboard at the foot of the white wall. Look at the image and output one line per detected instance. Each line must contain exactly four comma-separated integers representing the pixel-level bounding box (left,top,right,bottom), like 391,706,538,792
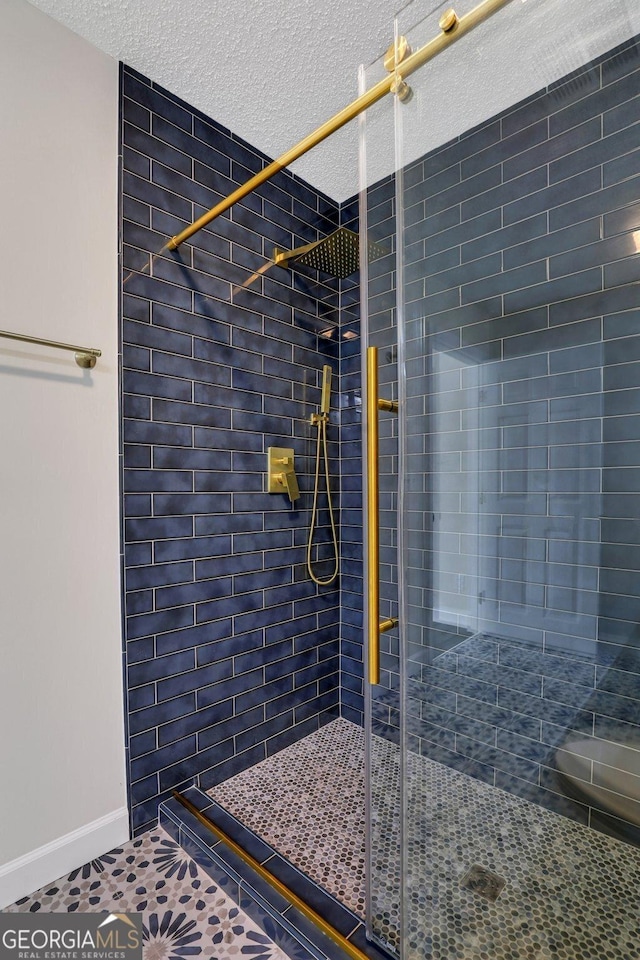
0,807,129,910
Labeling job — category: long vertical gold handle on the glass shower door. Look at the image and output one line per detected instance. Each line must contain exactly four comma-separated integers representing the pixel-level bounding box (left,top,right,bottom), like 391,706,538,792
367,347,398,684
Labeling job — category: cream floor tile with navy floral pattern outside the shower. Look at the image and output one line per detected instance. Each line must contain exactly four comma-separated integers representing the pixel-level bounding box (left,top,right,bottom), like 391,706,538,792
5,828,295,960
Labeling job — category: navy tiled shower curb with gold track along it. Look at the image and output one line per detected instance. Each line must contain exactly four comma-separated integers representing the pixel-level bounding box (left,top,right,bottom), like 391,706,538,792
159,787,389,960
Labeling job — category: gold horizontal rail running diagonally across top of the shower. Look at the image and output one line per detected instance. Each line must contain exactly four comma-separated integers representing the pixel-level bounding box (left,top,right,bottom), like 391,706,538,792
167,0,512,250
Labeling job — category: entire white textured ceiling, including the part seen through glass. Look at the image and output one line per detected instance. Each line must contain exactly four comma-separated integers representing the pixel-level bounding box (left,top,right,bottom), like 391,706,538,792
23,0,640,201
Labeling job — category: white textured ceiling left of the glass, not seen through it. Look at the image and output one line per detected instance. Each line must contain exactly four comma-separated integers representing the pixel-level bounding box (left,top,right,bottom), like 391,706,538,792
26,0,404,200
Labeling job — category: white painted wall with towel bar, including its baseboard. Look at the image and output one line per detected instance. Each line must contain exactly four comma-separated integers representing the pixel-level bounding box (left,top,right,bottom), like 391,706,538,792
0,0,128,907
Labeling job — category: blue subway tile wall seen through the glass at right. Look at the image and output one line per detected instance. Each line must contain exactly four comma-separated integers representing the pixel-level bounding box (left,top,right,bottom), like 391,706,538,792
367,40,640,839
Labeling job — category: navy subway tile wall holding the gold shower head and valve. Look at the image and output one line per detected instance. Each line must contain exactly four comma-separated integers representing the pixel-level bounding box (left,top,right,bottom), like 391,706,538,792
121,67,340,832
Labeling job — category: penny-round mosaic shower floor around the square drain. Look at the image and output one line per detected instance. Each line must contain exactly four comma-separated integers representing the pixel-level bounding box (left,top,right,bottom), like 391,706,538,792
209,719,640,960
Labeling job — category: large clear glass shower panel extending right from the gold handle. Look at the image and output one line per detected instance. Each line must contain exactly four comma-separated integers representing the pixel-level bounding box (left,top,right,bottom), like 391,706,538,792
361,0,640,960
